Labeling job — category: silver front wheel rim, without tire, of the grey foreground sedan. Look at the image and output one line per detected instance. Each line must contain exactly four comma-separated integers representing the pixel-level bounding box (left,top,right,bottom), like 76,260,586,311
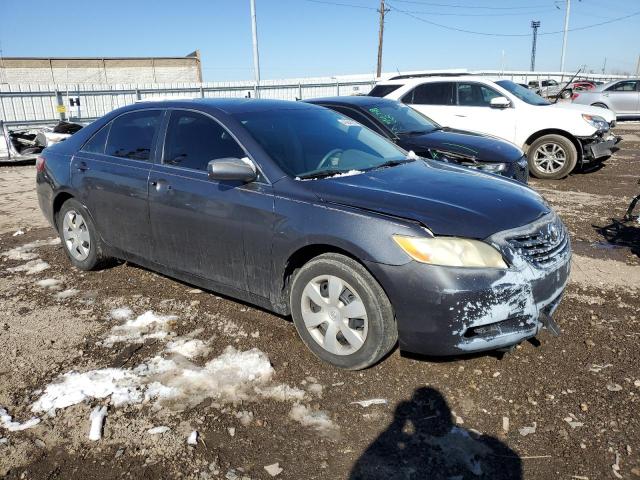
301,275,368,355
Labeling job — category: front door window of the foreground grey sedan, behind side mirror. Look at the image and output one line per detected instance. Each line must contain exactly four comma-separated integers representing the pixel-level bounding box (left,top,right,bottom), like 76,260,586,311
163,110,245,171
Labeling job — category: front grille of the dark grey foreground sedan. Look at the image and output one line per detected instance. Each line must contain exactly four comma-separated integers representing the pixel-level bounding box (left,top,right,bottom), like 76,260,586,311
509,219,569,267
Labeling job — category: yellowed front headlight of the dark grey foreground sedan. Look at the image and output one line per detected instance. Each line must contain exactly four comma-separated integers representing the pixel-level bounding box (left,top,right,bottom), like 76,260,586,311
393,235,507,268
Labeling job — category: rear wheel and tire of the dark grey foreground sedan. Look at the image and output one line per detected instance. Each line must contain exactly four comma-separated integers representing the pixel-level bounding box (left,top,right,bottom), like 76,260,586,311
56,198,106,271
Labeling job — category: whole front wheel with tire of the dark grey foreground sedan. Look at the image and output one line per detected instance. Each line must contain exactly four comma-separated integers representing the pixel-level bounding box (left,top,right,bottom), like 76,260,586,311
289,253,398,370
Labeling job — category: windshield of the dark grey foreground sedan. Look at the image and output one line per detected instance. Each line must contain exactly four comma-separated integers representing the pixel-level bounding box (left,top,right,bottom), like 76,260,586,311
233,107,408,178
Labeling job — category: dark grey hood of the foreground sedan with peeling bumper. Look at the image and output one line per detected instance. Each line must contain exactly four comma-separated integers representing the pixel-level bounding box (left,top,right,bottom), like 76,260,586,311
306,160,549,238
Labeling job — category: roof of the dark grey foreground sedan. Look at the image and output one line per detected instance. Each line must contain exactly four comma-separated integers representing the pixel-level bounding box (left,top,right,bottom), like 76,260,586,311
119,98,316,114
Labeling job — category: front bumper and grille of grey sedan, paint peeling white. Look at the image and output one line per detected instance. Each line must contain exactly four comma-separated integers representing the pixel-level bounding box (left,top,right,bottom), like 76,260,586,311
367,214,571,355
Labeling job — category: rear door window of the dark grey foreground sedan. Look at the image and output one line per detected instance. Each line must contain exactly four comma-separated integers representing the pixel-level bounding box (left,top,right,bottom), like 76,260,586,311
106,110,162,160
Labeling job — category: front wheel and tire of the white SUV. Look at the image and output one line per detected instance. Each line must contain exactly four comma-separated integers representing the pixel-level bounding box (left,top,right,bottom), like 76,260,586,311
527,135,578,180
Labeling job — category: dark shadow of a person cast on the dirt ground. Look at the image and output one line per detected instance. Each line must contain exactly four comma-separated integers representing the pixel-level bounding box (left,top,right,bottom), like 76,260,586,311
349,387,522,480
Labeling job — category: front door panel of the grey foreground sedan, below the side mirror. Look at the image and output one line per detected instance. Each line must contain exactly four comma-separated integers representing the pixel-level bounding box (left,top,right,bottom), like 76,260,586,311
149,110,273,296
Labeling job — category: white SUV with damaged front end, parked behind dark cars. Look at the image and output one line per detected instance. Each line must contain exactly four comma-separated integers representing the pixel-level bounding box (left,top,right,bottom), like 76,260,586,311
369,75,620,179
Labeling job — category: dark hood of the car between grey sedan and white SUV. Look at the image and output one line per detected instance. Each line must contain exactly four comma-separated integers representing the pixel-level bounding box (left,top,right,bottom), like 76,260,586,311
399,128,523,163
